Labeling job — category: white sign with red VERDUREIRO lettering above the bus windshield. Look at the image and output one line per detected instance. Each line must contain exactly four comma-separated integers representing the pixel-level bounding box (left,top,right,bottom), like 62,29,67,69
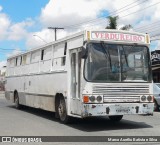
91,31,145,43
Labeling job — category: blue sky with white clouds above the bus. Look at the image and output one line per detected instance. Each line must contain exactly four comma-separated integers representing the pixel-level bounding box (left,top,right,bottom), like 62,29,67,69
0,0,160,68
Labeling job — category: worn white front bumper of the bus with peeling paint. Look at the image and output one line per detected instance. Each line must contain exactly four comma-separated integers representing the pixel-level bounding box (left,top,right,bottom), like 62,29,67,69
82,103,154,117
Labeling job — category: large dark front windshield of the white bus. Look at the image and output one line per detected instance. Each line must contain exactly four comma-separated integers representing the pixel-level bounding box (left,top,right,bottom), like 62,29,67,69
84,42,151,82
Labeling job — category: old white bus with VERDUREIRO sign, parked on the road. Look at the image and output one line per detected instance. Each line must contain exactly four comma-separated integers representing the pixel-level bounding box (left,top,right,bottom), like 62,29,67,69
5,29,154,123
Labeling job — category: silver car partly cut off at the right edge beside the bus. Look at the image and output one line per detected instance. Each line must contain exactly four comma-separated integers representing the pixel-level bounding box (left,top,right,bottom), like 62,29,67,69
153,83,160,111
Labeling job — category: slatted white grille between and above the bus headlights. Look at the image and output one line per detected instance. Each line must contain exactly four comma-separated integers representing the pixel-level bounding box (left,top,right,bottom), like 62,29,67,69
93,84,149,103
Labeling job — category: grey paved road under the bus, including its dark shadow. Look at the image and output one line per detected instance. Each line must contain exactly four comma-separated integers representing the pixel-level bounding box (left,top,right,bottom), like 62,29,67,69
0,93,160,145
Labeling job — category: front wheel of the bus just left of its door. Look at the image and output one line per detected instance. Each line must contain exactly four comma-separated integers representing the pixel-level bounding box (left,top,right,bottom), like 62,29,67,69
58,97,70,124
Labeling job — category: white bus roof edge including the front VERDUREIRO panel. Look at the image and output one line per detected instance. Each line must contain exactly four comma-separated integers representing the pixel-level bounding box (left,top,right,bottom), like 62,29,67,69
8,29,150,59
